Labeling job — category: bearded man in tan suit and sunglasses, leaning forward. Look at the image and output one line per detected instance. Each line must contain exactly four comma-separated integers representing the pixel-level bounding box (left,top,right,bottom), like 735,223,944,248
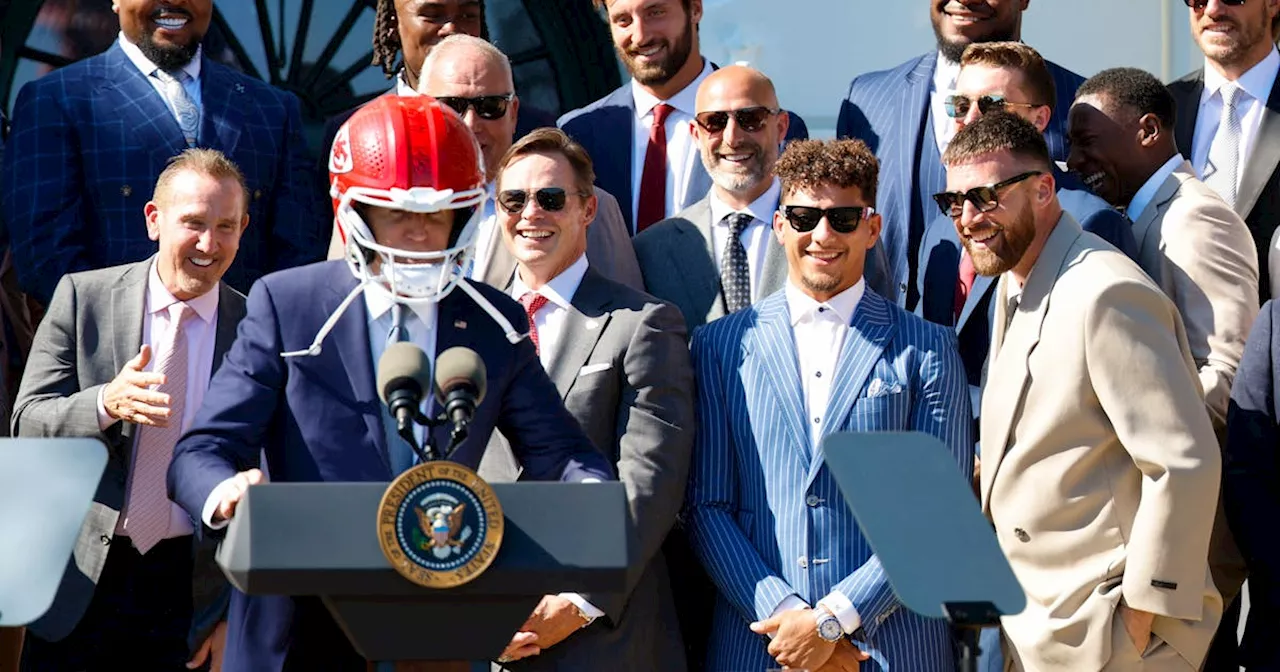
936,113,1222,672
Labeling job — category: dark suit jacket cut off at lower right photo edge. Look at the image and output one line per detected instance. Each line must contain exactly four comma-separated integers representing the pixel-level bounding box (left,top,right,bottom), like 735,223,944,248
1222,300,1280,669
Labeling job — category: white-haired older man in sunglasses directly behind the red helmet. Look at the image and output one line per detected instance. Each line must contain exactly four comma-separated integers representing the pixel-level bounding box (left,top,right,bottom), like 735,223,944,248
419,35,644,289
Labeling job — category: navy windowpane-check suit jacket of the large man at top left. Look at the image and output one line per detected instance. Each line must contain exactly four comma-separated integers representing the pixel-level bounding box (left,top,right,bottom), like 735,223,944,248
0,42,330,305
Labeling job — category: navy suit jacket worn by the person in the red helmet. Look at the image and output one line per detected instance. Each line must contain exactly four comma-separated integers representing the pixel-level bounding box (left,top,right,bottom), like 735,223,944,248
169,261,613,672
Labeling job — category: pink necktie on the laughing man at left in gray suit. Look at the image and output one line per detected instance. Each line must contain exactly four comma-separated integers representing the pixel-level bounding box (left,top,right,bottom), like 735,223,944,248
124,302,195,553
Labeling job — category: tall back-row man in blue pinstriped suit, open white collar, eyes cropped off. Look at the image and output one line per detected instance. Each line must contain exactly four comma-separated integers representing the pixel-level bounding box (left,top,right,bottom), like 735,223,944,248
836,0,1084,310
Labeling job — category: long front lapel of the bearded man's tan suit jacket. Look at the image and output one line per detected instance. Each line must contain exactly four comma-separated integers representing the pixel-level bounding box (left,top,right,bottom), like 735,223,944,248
980,212,1083,509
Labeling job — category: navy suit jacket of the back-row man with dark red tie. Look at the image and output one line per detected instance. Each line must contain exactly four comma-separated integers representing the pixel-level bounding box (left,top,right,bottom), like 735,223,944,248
557,63,809,232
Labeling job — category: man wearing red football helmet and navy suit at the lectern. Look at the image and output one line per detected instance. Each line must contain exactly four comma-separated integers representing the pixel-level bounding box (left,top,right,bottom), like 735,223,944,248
169,96,613,671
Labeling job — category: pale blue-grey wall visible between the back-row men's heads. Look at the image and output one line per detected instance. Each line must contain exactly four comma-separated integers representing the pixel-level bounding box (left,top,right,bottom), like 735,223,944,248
701,0,1202,137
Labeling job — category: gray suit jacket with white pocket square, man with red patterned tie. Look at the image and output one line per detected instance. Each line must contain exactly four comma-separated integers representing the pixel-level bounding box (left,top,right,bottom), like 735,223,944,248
479,268,694,672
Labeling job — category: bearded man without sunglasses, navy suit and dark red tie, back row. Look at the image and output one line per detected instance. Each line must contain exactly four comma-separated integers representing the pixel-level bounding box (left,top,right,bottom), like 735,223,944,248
558,0,809,234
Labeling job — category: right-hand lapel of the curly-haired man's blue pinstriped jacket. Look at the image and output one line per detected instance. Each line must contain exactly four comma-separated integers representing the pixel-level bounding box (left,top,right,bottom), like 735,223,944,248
814,292,895,489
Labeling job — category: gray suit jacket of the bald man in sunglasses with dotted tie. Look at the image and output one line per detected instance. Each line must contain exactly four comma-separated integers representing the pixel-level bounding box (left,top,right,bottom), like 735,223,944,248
632,195,787,332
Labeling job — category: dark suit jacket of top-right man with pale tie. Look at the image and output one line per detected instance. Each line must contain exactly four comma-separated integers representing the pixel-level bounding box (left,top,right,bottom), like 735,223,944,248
1169,68,1280,301
